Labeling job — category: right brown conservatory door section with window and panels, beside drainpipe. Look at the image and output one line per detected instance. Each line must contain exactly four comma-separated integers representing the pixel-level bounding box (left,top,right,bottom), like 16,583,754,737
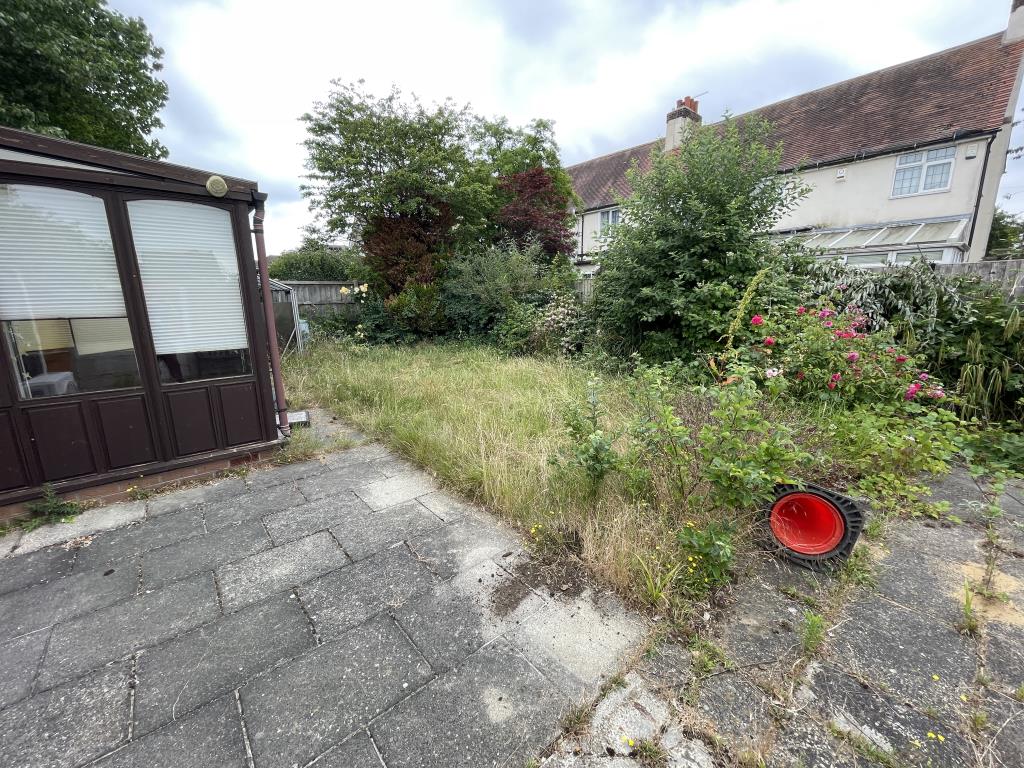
127,199,272,458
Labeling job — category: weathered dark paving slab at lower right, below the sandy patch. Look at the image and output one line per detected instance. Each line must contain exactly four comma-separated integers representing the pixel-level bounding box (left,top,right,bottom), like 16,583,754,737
829,596,976,717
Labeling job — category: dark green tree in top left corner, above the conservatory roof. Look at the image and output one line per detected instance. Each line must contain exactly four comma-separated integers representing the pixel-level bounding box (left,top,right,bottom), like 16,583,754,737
0,0,167,158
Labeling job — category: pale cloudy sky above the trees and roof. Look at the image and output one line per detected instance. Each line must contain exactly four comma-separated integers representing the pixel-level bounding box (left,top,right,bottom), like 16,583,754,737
111,0,1024,253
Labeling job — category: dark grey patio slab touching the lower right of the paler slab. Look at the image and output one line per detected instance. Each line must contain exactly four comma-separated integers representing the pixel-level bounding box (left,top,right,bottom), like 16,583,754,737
298,545,434,639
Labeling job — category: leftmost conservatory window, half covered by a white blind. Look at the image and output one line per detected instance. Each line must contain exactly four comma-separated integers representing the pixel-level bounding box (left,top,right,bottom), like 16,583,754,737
0,184,140,399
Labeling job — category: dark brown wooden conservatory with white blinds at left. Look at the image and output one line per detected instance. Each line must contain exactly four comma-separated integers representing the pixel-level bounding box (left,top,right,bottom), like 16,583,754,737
0,128,287,505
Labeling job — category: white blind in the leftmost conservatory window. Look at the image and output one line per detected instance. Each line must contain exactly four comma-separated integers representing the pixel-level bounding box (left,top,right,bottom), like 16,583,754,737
0,184,125,319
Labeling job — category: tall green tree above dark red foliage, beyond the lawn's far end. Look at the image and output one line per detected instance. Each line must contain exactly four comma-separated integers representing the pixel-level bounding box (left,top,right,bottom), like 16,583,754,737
302,81,571,295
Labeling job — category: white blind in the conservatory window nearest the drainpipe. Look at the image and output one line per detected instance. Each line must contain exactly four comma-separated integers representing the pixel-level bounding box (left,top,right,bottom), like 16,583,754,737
128,200,249,354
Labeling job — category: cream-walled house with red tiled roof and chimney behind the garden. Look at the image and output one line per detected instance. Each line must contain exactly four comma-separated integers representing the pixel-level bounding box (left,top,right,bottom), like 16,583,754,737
567,0,1024,275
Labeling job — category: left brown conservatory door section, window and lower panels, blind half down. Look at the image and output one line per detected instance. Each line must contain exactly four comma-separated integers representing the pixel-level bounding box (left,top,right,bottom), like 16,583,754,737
0,183,159,492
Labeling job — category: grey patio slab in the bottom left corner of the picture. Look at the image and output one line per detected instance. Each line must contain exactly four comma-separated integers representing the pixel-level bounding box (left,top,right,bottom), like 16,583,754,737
0,666,128,768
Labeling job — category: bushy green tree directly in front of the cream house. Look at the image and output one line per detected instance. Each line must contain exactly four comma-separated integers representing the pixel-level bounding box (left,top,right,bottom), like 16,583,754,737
594,116,806,358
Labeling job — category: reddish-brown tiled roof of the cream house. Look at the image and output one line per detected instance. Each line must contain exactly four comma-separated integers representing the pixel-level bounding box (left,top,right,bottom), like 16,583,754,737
566,33,1024,210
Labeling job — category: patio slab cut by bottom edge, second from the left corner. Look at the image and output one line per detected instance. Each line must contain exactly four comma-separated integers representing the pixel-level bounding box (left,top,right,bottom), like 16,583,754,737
90,694,248,768
